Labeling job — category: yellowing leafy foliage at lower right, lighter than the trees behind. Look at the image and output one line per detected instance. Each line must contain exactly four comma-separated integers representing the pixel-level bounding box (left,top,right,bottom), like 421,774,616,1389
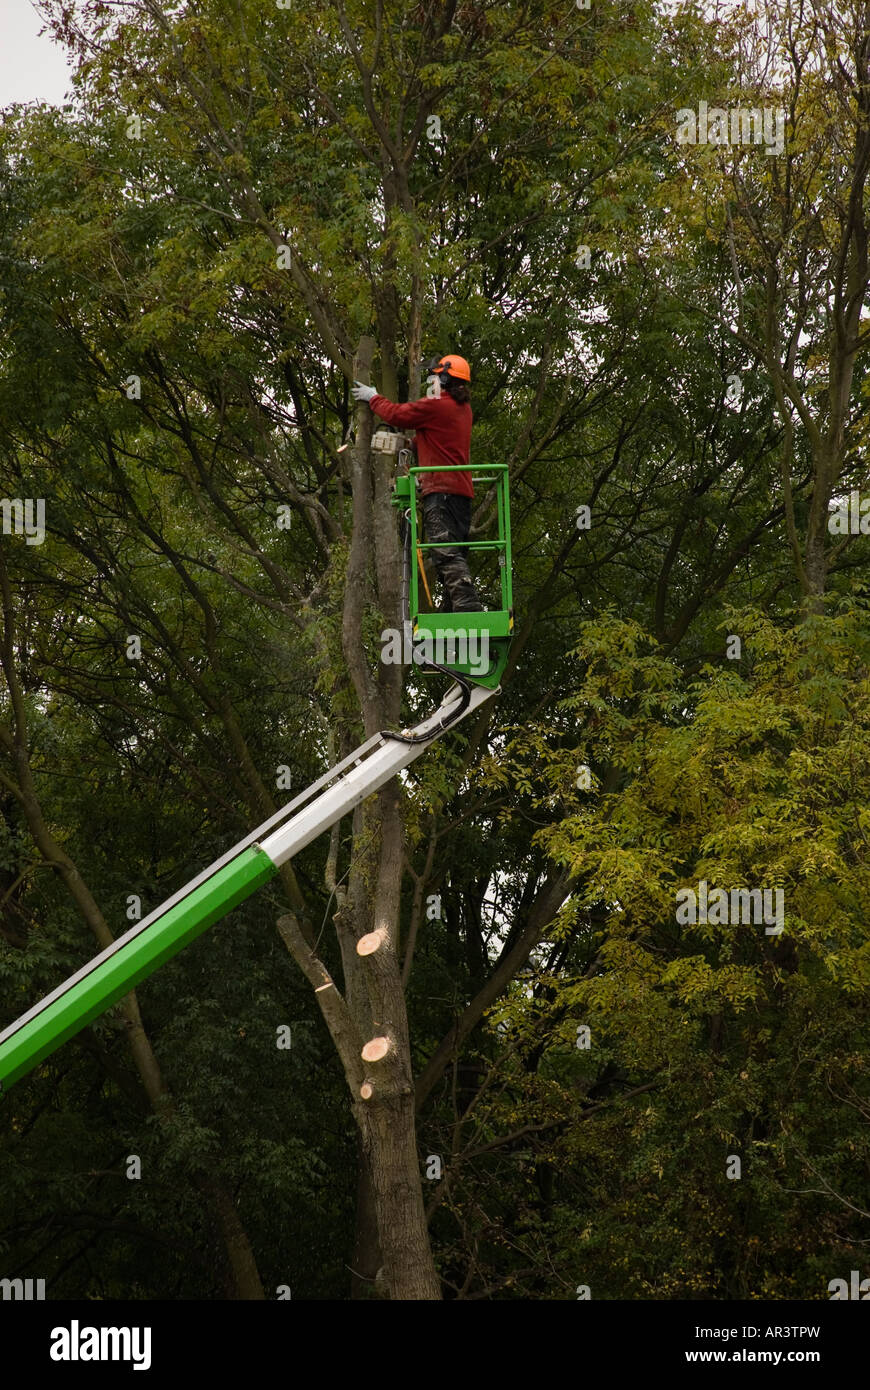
428,596,870,1298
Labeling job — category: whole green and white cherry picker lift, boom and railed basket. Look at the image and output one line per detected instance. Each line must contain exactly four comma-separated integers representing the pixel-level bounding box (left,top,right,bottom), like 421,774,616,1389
0,464,513,1091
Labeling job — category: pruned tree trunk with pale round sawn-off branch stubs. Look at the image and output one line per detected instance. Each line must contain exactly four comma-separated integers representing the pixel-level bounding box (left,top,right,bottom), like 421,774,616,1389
278,339,441,1300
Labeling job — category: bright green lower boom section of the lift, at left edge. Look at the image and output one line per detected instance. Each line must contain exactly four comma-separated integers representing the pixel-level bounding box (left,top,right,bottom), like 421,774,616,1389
0,848,278,1090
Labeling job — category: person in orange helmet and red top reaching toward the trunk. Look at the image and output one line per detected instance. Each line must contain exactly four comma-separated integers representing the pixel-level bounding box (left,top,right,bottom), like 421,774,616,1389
352,353,482,613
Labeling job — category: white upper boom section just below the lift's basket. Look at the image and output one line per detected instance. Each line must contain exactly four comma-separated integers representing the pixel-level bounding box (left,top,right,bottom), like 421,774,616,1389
258,685,498,866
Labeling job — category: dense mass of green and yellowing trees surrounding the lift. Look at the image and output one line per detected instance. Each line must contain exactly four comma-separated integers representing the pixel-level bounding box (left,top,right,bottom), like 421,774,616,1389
0,0,870,1300
